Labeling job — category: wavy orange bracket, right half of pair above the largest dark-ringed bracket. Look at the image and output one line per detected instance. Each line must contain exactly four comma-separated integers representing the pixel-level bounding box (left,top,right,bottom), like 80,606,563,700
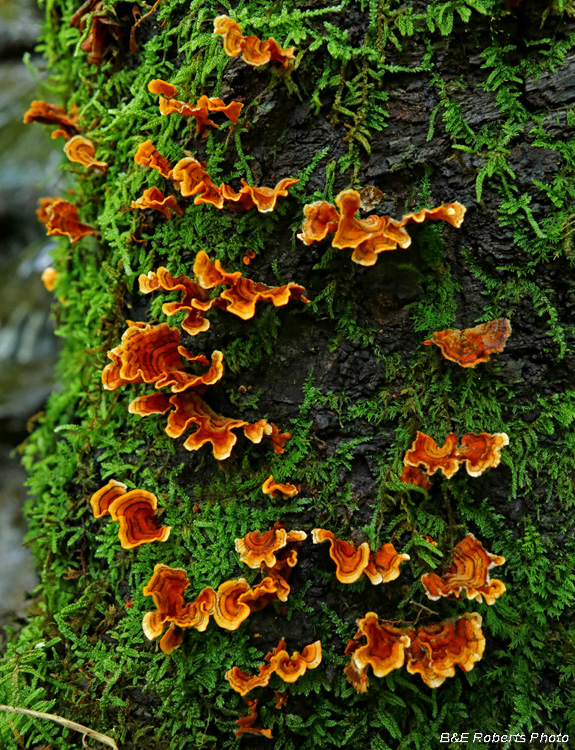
194,250,309,320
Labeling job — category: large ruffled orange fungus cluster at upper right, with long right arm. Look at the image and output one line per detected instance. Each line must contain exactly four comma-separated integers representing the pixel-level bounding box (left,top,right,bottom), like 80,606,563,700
297,190,466,266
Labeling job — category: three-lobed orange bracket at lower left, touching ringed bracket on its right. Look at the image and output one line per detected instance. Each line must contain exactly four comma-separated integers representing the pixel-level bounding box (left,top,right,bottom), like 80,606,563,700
142,563,216,654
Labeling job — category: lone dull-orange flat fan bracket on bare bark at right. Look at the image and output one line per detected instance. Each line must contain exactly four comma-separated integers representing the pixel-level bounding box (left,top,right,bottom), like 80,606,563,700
423,318,511,367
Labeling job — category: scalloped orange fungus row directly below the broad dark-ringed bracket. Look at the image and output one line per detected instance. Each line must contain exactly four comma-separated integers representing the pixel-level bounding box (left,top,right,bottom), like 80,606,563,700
128,391,289,461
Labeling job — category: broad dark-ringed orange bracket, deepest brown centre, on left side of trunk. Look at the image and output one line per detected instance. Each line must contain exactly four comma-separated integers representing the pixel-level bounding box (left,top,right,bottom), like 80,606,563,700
102,320,224,393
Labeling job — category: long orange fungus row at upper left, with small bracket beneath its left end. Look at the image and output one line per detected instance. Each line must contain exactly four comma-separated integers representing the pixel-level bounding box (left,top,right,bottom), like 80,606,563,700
132,137,299,219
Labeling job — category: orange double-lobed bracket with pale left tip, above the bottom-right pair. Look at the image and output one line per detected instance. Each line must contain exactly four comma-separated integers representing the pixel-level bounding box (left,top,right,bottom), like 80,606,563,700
312,529,409,586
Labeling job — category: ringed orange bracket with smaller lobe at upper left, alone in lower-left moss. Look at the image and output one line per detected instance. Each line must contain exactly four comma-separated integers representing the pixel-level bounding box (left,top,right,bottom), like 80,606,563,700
90,479,171,549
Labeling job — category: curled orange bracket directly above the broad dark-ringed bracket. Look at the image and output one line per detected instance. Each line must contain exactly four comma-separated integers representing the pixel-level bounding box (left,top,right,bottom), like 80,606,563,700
138,266,217,336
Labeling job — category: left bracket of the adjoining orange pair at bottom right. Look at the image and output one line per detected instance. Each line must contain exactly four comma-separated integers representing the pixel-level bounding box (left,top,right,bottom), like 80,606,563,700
344,612,411,693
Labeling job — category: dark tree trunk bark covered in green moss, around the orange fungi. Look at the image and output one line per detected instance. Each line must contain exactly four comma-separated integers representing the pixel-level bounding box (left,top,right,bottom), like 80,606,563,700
0,0,575,750
